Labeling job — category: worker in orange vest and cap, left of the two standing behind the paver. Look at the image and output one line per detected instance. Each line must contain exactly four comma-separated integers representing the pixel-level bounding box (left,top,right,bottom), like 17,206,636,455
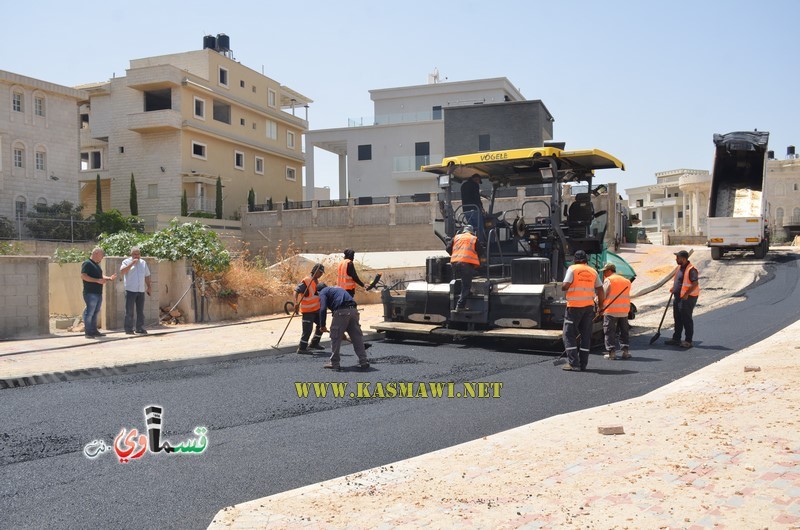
561,250,605,371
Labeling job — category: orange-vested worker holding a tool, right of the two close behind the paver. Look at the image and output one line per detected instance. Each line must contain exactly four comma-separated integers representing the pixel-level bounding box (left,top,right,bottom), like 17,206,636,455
601,263,631,361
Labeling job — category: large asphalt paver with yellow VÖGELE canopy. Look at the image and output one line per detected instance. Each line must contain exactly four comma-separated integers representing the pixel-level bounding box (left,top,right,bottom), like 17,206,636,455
373,144,635,349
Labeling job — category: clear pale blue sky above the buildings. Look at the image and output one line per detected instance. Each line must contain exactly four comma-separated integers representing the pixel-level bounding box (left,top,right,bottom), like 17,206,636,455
7,0,800,196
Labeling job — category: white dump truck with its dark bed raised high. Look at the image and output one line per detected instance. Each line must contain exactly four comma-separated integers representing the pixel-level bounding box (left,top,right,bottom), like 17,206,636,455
707,131,769,260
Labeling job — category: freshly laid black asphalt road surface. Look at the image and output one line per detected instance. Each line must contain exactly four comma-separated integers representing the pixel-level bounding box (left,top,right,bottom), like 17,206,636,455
0,253,800,528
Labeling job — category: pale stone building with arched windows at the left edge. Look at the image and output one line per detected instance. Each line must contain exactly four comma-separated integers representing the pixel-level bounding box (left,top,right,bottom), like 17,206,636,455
0,70,86,227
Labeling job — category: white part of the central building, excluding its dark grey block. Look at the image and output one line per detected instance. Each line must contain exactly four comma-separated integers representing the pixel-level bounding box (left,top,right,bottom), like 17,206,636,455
305,77,525,200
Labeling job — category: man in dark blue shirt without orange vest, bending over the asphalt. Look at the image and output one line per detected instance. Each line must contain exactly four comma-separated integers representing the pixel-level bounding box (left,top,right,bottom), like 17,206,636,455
319,287,369,371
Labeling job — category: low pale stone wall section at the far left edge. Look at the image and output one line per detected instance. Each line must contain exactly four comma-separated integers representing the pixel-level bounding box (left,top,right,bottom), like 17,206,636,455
0,256,50,339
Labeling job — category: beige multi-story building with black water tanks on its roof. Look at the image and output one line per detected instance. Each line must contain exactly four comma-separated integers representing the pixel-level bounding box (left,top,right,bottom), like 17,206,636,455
80,35,311,219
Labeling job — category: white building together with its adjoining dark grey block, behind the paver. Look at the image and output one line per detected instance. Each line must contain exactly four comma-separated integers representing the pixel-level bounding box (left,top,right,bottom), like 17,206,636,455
306,77,553,200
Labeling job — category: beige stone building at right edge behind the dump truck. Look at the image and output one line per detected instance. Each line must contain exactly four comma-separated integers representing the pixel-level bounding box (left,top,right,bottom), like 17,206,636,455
765,146,800,240
